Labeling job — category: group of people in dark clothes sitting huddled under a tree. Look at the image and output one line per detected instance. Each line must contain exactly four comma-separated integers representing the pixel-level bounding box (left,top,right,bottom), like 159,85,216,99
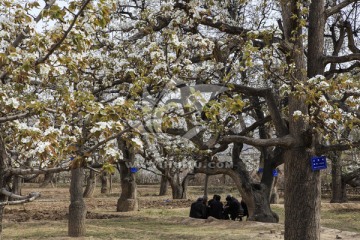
190,194,249,221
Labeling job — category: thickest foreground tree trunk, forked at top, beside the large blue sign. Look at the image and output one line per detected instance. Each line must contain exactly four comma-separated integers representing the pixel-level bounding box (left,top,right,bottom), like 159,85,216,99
280,0,325,240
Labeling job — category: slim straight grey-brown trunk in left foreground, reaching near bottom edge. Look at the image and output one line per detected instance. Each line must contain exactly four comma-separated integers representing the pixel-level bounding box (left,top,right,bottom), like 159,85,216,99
68,167,86,237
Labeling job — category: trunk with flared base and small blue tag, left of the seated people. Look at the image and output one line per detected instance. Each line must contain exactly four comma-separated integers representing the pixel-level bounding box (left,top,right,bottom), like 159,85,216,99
116,139,139,212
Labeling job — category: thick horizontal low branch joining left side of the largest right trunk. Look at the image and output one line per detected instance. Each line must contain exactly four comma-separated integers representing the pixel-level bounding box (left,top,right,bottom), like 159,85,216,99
220,135,295,148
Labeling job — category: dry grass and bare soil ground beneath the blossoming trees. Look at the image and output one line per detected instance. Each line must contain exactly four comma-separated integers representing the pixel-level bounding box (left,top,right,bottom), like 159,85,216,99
3,185,360,240
